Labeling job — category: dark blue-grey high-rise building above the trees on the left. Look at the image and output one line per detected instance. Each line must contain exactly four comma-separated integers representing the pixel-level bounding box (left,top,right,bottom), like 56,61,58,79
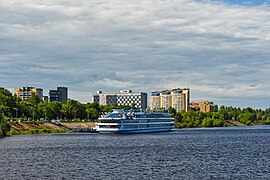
49,87,68,103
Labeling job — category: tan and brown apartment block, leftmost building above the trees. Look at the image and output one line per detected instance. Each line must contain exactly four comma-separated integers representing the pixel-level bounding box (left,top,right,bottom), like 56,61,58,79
14,86,43,100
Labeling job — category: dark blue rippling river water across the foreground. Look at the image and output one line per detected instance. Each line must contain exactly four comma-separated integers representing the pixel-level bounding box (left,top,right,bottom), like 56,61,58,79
0,126,270,180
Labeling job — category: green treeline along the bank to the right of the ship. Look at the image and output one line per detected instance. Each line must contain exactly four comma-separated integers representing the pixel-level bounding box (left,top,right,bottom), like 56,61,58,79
170,106,270,128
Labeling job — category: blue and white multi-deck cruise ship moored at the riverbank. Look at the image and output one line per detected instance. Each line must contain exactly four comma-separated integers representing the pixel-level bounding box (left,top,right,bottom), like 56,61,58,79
96,109,175,133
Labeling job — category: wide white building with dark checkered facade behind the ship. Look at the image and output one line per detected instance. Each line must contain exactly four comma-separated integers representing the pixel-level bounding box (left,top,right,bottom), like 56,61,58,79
92,90,147,110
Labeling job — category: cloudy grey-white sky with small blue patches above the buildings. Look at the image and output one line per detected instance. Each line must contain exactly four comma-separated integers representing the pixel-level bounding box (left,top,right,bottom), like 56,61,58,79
0,0,270,109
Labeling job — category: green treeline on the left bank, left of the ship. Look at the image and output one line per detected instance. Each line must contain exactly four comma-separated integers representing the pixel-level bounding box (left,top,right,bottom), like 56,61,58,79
0,87,130,121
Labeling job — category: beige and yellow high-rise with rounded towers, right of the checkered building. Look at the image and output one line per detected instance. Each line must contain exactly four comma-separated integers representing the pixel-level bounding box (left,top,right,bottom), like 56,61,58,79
150,88,190,112
